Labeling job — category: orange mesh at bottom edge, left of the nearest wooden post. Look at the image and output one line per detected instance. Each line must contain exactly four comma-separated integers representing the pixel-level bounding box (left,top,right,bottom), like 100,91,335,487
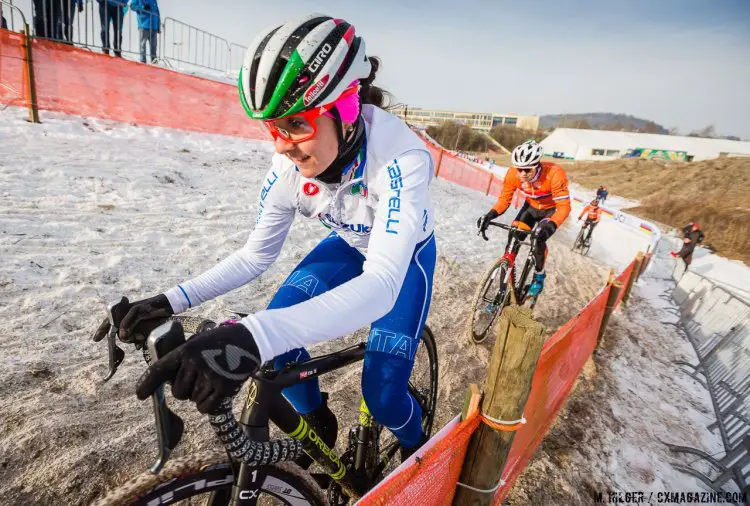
357,413,479,506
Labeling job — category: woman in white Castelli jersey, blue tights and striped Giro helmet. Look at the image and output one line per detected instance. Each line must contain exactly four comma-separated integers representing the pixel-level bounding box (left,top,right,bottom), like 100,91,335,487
95,15,436,466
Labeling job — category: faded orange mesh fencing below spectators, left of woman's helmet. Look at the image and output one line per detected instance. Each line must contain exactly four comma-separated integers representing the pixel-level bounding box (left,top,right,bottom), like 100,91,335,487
8,33,270,140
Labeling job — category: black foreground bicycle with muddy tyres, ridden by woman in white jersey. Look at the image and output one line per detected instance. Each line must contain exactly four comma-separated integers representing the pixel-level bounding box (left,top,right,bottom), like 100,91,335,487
94,298,438,506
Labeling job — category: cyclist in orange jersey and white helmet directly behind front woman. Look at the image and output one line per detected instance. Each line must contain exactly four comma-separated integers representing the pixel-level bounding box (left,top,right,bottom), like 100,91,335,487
477,140,570,296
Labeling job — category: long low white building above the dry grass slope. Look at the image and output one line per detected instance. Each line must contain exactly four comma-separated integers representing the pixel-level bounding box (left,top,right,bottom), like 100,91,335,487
541,128,750,160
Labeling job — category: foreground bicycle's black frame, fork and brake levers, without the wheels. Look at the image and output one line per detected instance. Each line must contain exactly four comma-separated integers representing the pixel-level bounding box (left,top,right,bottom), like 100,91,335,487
100,297,428,506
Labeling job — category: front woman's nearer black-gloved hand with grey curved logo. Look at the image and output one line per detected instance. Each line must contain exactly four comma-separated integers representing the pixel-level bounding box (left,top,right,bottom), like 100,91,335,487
136,323,260,413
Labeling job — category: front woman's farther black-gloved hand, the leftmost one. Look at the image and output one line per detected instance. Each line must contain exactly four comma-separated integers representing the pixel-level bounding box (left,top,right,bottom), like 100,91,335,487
94,293,174,343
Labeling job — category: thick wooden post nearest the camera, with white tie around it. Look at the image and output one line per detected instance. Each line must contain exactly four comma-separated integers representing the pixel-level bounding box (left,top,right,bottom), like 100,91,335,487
453,306,545,506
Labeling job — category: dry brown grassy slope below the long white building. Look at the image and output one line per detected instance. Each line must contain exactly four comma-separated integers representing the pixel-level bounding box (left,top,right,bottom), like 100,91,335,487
566,157,750,263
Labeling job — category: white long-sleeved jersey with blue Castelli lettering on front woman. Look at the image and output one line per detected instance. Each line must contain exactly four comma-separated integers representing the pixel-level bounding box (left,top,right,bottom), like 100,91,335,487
166,105,434,362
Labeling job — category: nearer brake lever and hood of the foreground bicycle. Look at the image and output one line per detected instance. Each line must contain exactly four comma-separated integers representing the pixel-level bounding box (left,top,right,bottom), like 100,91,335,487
146,320,185,474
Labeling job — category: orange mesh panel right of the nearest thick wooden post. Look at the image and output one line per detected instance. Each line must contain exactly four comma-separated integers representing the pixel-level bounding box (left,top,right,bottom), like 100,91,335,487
493,287,609,505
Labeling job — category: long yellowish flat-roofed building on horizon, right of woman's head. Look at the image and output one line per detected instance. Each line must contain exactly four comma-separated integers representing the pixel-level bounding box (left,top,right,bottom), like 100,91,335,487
392,106,539,132
